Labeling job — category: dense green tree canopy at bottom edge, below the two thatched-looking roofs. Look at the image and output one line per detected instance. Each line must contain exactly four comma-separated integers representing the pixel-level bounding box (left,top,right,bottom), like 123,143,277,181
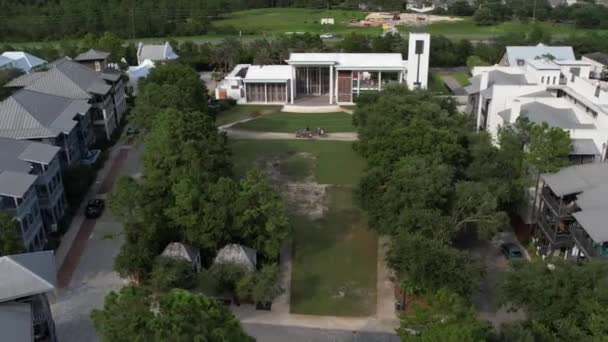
91,286,253,342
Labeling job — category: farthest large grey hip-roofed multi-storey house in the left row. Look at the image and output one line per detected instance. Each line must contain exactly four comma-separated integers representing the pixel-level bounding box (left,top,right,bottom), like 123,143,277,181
6,58,127,140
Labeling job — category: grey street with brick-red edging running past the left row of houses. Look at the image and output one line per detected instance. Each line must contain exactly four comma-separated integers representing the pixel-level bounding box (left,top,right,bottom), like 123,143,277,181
51,142,141,342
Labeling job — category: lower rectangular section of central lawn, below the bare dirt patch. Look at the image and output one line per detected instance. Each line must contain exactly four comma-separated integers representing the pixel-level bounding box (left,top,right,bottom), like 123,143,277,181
290,187,378,316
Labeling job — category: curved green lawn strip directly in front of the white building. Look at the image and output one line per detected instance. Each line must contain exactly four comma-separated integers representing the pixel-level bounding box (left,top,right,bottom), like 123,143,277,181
234,112,356,133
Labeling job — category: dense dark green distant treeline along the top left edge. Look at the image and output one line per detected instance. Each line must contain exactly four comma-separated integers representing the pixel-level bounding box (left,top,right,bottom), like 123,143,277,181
0,0,405,42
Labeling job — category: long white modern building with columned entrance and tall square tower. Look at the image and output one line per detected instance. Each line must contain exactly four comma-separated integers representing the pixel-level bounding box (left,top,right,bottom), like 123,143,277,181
216,33,430,105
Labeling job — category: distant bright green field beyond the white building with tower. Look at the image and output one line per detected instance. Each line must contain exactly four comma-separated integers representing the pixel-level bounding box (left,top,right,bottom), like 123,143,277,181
213,8,382,36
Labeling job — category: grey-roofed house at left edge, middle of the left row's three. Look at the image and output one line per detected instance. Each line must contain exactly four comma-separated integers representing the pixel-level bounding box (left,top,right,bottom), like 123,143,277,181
0,89,95,166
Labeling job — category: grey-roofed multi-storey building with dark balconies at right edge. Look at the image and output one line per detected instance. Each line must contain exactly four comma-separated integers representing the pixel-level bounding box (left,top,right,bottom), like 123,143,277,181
534,163,608,259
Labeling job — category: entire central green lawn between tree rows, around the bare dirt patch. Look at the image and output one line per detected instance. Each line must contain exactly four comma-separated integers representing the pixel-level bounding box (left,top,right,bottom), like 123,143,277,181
231,140,378,316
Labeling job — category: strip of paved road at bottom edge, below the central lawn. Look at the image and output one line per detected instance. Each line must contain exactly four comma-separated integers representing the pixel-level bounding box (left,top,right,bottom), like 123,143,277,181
243,324,399,342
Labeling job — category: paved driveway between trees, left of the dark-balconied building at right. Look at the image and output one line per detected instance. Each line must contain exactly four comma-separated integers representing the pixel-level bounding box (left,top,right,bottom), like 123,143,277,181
471,232,525,329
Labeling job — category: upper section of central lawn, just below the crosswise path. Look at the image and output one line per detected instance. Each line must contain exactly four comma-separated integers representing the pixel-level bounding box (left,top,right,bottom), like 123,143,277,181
230,140,365,186
